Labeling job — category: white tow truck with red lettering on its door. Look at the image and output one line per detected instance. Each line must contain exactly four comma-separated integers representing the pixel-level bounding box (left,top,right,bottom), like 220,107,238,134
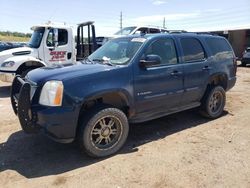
0,22,98,82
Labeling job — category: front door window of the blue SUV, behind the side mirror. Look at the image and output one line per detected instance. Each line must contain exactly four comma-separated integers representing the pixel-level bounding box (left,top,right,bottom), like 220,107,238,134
145,39,177,65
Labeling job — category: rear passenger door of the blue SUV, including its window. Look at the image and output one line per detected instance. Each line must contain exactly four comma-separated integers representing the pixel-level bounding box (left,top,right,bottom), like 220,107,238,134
179,37,211,106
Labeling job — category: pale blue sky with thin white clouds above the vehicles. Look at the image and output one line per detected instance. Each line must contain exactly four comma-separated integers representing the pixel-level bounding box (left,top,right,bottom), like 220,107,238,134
0,0,250,35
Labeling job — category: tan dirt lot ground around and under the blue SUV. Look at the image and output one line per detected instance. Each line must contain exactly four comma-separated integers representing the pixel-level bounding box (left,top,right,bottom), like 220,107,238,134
0,67,250,188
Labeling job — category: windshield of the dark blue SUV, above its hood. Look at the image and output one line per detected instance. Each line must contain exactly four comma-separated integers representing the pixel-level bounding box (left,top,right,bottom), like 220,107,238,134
88,38,146,65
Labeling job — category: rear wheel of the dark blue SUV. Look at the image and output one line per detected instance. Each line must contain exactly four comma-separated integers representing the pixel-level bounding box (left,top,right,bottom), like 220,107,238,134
200,86,226,119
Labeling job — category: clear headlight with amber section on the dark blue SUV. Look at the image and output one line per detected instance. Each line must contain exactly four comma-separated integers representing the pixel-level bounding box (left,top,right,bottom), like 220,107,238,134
39,80,63,106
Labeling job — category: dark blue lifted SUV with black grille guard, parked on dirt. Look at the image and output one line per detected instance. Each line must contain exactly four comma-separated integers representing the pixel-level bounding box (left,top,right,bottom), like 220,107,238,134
11,33,236,157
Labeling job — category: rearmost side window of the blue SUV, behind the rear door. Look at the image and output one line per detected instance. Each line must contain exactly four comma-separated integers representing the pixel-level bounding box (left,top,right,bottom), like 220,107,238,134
206,38,233,60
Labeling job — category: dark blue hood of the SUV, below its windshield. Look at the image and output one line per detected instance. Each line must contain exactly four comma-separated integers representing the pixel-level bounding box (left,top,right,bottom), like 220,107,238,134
27,62,115,84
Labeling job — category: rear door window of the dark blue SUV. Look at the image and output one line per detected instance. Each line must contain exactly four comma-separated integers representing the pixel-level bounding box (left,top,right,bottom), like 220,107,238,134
181,38,205,62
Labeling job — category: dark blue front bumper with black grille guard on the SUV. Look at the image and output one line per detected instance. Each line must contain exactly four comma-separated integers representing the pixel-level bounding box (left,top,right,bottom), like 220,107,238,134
11,76,78,143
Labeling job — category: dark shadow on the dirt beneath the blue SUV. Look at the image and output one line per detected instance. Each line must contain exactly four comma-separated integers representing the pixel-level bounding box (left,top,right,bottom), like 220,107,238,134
0,110,227,178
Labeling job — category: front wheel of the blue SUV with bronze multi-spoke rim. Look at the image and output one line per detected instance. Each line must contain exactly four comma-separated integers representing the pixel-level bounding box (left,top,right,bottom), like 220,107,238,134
78,105,129,157
